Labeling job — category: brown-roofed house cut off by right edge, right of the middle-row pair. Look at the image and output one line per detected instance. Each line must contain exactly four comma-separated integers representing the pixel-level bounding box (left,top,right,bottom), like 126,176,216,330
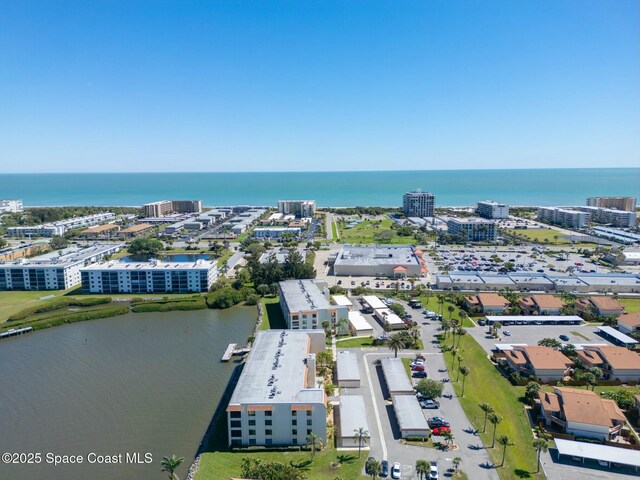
577,345,640,382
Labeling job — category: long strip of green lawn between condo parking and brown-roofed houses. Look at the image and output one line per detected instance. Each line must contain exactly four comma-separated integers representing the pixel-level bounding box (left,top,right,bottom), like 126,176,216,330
445,335,544,480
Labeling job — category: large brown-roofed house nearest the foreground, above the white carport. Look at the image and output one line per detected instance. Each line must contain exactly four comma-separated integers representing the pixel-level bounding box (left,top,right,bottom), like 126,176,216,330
538,387,627,440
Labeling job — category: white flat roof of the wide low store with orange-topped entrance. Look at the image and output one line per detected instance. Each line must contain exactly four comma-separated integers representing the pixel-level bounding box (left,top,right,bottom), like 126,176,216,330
335,245,420,267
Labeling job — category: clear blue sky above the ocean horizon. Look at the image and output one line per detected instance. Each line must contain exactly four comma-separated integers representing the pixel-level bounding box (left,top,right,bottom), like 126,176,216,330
0,0,640,172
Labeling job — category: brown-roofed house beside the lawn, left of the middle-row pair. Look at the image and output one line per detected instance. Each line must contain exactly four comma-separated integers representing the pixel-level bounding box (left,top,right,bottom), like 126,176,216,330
505,345,573,382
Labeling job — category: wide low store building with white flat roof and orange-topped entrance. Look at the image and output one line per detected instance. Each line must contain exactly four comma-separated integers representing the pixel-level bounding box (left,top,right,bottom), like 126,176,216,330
333,245,423,278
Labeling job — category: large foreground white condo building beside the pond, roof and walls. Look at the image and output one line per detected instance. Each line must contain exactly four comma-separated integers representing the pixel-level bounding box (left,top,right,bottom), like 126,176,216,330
227,330,327,446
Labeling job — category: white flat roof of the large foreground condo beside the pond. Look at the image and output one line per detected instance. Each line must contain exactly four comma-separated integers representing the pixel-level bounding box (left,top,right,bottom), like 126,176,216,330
229,330,324,405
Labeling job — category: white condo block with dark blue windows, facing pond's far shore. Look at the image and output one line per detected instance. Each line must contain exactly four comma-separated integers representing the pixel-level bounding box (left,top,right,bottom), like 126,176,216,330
80,260,218,293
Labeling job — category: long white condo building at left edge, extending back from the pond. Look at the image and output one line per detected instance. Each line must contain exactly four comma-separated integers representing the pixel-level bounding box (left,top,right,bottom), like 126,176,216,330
0,244,123,290
